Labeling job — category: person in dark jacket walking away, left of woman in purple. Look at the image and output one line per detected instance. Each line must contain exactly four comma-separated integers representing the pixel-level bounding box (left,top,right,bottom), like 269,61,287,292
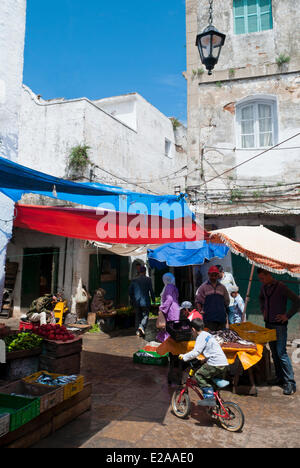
129,266,155,336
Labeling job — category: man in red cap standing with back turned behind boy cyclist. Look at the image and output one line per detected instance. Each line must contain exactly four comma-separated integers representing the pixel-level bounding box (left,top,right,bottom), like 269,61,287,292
195,266,230,331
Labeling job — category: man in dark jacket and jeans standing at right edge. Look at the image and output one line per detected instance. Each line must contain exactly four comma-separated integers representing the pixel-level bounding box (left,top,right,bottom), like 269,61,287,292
257,268,300,395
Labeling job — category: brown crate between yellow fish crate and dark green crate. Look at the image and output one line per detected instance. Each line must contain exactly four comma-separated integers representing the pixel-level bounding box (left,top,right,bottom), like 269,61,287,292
0,380,64,413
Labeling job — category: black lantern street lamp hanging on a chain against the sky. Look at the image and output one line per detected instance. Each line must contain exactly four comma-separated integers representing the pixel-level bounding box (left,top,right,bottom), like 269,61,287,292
196,0,226,75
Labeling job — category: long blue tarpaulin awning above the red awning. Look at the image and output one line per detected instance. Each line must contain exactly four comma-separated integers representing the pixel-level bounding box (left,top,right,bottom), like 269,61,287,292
0,157,194,219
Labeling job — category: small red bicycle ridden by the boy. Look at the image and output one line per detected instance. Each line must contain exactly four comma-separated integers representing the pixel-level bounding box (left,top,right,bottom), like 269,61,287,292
172,359,245,432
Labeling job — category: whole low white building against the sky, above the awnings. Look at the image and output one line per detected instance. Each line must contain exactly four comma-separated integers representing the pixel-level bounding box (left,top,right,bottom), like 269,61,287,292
19,86,186,193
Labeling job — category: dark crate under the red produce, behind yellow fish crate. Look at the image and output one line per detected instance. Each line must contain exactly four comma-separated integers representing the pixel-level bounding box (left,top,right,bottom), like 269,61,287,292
40,353,81,375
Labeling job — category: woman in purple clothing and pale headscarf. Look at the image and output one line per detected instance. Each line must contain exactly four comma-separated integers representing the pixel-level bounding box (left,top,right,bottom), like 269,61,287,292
156,273,180,342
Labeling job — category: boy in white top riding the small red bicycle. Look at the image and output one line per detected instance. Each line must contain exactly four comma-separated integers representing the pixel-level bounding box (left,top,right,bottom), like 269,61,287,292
179,319,228,406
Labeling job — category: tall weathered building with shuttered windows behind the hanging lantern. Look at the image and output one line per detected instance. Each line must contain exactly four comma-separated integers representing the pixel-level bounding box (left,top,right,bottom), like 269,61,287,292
184,0,300,336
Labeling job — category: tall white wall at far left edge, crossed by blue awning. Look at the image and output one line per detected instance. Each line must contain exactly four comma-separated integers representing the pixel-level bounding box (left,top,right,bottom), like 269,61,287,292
0,0,26,306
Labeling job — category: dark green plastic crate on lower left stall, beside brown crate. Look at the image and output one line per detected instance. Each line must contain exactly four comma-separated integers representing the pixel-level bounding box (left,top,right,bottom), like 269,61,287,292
0,393,40,432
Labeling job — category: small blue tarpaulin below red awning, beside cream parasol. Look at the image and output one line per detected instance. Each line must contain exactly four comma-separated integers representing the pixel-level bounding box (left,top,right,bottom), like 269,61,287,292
148,240,229,270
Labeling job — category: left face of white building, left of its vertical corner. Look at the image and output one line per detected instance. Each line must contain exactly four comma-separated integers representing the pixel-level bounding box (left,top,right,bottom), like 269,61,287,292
19,87,86,177
